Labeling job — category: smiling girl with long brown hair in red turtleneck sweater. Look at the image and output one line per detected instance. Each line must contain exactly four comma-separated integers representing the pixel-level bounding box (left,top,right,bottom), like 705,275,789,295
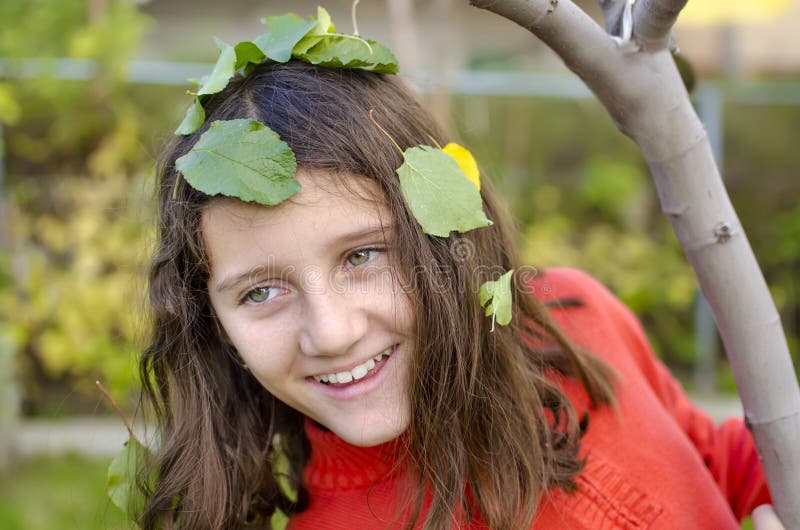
140,52,769,529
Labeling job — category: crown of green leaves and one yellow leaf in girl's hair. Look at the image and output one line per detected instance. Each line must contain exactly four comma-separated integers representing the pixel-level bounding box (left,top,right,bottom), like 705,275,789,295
175,7,511,329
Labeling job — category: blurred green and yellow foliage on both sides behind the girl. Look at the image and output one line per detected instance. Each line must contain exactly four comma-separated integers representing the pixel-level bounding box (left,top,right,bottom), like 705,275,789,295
0,0,800,414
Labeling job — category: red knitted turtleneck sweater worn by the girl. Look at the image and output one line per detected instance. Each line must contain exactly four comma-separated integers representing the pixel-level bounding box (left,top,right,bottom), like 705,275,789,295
289,269,769,530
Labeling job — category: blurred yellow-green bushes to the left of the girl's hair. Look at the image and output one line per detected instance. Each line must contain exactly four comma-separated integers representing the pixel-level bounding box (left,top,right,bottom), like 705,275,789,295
0,0,183,414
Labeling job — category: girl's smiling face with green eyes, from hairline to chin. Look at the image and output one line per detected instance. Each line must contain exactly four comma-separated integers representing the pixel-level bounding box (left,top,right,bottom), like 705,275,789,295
202,170,414,446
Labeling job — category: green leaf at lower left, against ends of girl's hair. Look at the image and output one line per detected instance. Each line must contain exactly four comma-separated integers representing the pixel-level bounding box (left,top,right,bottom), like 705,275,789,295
107,438,157,521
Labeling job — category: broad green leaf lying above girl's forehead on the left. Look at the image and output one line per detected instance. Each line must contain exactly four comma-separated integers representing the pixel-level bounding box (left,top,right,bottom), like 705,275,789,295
175,119,300,206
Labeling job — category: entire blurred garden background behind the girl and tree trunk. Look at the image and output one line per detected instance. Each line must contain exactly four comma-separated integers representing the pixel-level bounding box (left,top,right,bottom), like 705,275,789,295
0,0,800,529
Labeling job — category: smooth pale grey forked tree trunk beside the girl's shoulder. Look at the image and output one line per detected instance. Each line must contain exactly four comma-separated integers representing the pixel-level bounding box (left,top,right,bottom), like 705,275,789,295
472,0,800,530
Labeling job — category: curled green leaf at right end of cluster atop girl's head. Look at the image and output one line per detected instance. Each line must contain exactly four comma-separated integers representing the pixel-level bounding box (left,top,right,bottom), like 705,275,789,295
295,36,397,74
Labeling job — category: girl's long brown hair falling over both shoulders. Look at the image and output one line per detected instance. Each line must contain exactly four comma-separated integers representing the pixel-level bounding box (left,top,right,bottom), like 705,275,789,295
140,62,613,529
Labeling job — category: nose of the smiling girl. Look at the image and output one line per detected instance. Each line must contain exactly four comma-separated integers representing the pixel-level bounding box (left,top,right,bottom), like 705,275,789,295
300,276,368,356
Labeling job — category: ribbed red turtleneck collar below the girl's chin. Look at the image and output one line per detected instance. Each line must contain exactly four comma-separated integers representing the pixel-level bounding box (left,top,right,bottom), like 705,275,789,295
303,418,405,491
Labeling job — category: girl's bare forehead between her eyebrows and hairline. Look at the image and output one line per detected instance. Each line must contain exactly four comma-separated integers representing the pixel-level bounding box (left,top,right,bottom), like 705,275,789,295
202,169,391,270
